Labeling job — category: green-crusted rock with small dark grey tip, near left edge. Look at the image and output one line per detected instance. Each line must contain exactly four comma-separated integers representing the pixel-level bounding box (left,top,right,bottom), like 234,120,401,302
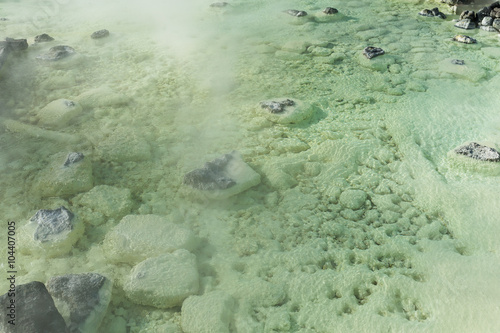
33,152,94,198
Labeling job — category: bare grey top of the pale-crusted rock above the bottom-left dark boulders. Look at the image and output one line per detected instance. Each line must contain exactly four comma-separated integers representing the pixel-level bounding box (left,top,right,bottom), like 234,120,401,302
30,206,74,242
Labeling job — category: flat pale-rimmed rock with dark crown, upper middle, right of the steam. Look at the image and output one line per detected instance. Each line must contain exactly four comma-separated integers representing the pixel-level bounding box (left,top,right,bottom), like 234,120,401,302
259,97,314,124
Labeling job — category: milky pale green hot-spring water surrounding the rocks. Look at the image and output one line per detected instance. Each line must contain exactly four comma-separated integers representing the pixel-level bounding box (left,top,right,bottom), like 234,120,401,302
0,0,500,332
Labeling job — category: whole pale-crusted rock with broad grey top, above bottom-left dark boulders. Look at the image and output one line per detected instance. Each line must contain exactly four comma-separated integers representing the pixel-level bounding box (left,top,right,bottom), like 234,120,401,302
20,206,84,257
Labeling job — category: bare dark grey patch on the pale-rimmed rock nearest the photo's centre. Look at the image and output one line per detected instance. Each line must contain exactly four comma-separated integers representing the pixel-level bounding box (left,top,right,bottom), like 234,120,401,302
184,153,236,190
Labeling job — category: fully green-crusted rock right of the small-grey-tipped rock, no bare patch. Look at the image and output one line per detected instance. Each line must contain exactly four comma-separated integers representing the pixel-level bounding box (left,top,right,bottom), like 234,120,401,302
72,185,134,225
